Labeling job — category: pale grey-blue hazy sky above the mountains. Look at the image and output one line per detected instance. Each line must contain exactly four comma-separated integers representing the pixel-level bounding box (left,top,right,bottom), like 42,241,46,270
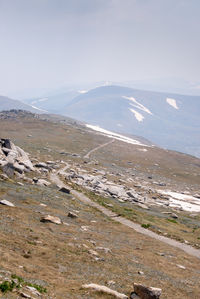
0,0,200,95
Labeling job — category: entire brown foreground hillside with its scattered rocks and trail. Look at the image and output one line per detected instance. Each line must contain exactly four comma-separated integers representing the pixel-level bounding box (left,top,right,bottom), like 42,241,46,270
0,111,200,299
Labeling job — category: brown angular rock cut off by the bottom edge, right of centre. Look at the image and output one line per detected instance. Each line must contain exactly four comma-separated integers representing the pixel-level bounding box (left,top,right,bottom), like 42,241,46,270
133,283,162,299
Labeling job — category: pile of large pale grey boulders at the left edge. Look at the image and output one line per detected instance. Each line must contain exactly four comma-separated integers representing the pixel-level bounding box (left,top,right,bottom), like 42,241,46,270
0,138,34,176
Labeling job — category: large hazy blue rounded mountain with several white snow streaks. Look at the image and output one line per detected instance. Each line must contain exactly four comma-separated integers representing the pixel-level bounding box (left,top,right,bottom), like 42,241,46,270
60,86,200,157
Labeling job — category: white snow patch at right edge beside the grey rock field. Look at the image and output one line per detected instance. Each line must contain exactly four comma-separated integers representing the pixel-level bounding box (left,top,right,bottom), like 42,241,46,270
158,190,200,212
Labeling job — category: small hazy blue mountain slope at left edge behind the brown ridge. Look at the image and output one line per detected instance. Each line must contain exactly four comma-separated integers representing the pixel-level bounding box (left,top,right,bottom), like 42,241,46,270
0,96,45,113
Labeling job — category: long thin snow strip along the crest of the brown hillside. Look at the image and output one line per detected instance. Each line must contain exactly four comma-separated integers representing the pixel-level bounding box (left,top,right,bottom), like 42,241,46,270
86,124,149,147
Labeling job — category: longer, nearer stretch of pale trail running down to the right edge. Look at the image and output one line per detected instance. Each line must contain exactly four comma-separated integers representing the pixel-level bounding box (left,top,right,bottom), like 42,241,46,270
50,166,200,259
